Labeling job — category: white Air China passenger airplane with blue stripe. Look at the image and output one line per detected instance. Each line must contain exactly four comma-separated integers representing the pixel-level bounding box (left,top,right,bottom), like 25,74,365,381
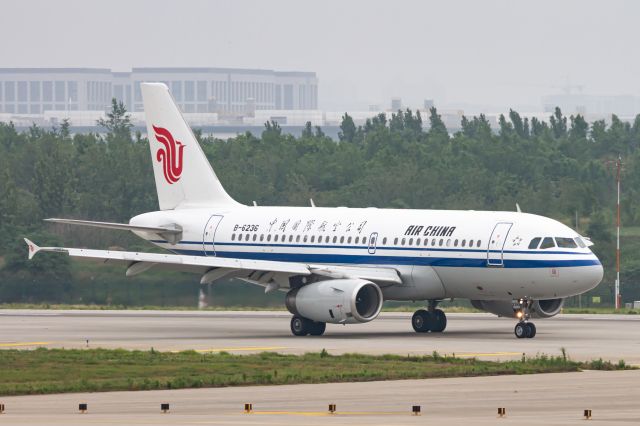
25,83,603,338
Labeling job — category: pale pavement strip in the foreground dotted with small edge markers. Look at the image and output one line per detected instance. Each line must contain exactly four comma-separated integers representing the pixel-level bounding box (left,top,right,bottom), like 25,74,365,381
0,370,640,426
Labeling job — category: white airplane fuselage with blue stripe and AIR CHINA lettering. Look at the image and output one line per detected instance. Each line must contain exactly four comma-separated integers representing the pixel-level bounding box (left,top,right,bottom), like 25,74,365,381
130,206,603,300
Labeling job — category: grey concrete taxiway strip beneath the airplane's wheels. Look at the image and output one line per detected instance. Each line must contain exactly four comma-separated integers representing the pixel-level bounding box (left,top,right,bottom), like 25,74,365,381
0,310,640,365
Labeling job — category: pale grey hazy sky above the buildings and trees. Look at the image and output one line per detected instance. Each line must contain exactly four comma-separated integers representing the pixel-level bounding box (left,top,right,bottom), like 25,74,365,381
0,0,640,111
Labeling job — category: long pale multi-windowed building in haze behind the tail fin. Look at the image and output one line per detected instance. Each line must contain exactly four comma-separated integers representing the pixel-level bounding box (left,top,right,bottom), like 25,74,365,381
0,68,318,116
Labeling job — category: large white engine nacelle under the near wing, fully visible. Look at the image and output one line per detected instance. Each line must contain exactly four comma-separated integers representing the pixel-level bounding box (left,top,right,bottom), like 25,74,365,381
285,279,384,324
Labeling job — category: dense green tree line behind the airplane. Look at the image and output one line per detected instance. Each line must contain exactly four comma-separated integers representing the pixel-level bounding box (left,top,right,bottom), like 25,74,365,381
0,101,640,302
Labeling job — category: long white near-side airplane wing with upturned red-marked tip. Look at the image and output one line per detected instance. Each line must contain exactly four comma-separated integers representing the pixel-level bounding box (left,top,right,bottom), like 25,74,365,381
24,238,402,288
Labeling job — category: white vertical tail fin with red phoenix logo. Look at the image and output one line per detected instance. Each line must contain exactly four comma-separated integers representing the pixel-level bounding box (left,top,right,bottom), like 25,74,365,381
141,83,238,210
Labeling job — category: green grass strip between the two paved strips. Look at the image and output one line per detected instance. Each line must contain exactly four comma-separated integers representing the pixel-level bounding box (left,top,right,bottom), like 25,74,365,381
0,348,629,396
